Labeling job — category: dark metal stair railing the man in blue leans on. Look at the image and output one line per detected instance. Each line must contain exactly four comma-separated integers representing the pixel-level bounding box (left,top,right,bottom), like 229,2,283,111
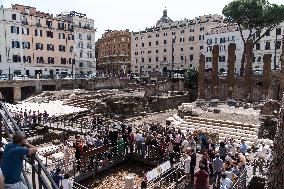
0,102,85,189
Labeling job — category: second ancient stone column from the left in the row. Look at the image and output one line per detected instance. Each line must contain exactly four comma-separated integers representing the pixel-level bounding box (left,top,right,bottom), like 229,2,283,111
211,45,219,98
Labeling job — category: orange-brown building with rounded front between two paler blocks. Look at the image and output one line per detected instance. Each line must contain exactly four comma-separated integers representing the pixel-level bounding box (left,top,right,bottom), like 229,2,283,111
97,30,131,74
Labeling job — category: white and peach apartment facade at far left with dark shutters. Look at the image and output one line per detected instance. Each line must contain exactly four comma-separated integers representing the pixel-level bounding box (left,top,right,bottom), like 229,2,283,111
0,4,96,76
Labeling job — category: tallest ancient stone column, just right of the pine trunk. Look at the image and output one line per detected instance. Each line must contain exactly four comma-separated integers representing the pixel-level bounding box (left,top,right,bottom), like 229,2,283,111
244,40,253,100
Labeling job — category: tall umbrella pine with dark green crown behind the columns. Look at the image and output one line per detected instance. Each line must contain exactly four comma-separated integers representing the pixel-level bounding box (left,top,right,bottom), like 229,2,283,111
223,0,284,76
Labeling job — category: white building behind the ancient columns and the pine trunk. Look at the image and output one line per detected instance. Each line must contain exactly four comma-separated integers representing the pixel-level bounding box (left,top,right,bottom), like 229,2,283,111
204,23,284,73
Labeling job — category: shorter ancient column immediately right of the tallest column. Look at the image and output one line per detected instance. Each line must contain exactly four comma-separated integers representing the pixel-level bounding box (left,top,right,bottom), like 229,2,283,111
262,54,272,99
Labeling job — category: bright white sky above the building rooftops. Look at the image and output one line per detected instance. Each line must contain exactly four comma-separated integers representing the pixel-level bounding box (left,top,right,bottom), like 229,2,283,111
0,0,284,39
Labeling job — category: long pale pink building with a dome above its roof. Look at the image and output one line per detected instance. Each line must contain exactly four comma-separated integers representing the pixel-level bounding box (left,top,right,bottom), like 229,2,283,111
131,10,223,75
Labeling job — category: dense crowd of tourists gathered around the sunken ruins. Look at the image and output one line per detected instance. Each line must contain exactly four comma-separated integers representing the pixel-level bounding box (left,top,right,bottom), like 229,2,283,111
52,117,248,189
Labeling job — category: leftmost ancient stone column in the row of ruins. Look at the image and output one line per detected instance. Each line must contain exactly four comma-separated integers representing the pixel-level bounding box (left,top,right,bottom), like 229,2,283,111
198,54,205,99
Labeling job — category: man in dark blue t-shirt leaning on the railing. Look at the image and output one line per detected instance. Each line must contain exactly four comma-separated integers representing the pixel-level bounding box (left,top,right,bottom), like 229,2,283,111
1,132,37,189
